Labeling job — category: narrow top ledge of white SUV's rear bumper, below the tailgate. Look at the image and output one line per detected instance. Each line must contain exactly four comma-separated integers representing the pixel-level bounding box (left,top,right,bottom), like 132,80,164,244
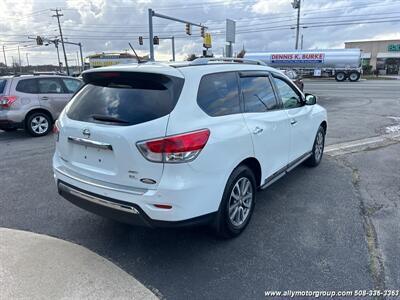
54,167,148,195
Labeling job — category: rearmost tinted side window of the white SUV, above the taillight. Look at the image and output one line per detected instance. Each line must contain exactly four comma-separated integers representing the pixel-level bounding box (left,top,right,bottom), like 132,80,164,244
197,72,240,117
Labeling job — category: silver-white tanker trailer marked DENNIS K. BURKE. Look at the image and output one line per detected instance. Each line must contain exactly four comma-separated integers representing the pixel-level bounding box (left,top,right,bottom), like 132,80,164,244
244,49,362,81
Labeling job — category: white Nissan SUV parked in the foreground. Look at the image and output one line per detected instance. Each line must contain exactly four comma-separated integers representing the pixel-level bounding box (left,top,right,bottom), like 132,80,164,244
53,59,327,237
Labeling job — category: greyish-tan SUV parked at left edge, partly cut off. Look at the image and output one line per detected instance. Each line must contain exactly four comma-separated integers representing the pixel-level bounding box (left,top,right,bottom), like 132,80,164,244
0,74,82,137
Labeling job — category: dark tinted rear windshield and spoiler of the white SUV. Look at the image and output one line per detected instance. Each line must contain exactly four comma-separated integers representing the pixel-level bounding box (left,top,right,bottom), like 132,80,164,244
67,72,184,126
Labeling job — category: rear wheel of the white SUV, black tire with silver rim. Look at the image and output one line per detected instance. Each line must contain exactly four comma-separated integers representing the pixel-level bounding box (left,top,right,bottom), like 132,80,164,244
215,165,256,238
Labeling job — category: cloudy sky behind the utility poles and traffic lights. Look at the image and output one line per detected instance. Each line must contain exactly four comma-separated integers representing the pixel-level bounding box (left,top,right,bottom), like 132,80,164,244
0,0,400,65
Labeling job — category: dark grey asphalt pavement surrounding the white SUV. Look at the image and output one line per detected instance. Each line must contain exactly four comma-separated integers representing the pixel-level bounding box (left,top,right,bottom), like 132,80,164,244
0,80,400,299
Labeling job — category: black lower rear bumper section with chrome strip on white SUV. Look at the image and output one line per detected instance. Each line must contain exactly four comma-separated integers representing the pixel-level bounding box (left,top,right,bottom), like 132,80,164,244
57,180,215,228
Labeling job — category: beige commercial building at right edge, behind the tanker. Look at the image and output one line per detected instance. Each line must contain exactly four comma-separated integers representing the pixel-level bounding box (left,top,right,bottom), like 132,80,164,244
344,40,400,75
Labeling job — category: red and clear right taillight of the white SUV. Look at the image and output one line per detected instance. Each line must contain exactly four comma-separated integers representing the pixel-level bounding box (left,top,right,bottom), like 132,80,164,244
137,129,210,163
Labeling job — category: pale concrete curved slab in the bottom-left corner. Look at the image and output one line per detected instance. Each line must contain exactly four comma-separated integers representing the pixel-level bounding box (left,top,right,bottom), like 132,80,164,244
0,228,158,300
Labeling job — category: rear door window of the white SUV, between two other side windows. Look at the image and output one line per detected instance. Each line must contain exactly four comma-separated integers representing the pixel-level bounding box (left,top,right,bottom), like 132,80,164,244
240,76,277,112
